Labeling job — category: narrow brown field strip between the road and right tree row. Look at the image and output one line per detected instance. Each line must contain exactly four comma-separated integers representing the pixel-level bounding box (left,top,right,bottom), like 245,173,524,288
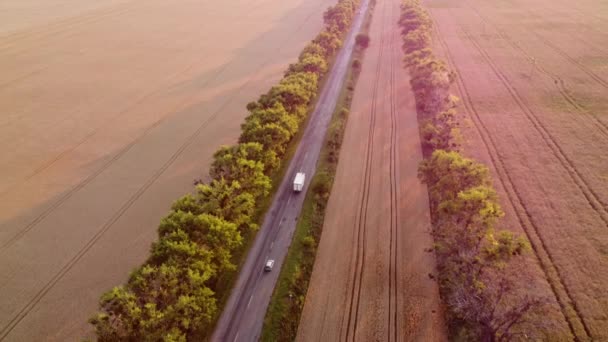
298,0,445,341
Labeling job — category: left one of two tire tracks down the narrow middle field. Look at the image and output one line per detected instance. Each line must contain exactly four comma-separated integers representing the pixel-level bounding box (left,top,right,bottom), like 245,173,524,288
340,1,386,341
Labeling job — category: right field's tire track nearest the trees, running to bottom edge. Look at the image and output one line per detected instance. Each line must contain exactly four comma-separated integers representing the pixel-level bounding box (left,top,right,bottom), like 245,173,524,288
428,11,591,341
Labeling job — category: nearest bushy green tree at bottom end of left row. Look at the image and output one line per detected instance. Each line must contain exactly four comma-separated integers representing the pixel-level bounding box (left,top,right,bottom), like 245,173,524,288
90,264,217,342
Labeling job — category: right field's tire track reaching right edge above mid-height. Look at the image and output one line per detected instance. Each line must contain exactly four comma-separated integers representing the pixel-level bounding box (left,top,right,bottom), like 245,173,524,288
468,5,608,138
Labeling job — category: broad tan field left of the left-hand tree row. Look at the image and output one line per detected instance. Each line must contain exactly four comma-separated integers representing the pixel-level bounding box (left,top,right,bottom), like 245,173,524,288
0,0,334,341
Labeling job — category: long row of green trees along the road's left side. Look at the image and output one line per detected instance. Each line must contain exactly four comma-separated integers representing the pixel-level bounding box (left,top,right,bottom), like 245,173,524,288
90,0,358,341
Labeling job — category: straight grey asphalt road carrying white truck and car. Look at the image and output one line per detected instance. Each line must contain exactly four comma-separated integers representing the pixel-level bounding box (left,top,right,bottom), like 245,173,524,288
212,0,369,342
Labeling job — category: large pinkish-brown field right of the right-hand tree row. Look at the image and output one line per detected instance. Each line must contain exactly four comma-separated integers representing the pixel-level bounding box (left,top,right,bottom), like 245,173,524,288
425,0,608,341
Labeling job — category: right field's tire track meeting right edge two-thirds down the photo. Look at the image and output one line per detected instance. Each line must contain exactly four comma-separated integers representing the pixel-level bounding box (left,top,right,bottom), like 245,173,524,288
461,27,608,227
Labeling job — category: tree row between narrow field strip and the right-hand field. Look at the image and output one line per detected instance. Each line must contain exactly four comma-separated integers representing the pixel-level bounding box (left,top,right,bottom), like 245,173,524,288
399,0,541,341
